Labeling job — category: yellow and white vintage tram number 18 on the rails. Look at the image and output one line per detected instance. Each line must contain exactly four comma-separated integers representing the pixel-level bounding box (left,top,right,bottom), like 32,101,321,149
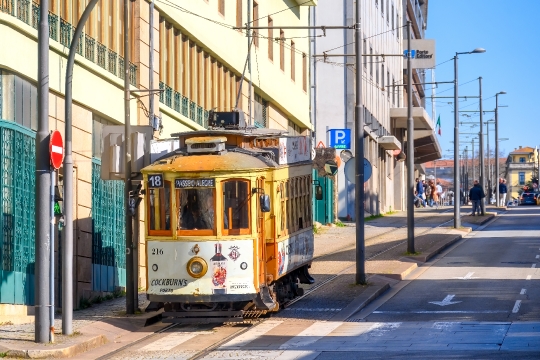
142,119,314,323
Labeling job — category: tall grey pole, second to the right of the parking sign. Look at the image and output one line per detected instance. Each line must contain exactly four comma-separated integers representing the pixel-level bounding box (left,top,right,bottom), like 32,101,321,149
407,21,415,254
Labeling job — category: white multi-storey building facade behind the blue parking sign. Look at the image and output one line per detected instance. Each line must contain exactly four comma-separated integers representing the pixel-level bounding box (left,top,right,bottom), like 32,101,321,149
311,0,441,219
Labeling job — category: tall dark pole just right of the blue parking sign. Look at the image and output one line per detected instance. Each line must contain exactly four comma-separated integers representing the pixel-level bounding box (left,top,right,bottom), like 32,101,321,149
354,1,366,284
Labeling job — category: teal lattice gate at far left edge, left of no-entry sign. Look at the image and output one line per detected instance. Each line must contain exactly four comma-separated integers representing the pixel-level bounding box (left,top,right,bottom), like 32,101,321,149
0,120,36,305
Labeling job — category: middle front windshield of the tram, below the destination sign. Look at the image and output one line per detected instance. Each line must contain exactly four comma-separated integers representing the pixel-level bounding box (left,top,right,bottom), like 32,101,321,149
176,189,216,230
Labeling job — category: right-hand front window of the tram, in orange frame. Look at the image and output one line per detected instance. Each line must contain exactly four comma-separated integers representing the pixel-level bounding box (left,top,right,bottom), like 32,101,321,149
223,180,250,230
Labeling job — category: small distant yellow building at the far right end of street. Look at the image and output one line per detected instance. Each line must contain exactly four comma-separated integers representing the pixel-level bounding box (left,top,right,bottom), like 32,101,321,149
505,146,539,199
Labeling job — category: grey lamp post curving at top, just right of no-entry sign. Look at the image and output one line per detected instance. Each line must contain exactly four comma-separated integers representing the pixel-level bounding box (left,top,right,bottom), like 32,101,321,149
64,0,99,335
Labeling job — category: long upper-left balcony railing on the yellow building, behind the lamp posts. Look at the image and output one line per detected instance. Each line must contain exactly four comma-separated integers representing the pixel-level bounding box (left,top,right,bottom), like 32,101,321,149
6,0,137,86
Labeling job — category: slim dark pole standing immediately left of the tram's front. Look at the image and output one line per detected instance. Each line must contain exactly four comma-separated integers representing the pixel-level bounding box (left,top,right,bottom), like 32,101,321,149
124,0,138,314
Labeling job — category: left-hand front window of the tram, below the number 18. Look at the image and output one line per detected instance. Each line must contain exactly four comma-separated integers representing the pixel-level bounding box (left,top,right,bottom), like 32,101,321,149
148,181,171,231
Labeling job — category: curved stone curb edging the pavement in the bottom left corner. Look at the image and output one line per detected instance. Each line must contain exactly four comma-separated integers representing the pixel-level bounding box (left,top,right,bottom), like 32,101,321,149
5,335,107,359
